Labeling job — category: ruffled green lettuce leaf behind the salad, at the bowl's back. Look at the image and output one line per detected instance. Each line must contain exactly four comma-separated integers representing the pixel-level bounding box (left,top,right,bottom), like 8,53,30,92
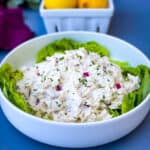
36,38,110,63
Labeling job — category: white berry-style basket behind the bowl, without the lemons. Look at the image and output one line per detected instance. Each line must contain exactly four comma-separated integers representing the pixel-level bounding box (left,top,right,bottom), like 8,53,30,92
40,0,114,33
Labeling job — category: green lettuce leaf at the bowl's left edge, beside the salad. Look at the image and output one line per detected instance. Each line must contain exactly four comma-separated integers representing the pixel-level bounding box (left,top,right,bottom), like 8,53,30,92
0,64,32,113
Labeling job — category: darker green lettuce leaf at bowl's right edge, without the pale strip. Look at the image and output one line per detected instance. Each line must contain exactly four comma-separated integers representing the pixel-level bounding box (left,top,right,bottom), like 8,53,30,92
121,65,150,113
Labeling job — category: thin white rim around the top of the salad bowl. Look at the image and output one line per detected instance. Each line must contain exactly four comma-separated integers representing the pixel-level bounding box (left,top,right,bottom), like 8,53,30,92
0,31,150,127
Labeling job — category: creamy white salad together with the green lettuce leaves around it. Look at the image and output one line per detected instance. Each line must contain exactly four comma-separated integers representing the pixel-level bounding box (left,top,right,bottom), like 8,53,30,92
0,38,150,123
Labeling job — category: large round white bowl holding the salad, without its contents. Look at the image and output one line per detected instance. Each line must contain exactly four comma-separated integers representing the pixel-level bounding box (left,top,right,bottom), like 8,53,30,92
0,32,150,148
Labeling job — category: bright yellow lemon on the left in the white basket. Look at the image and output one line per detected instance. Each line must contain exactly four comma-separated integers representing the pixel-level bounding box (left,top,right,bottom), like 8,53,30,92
44,0,77,9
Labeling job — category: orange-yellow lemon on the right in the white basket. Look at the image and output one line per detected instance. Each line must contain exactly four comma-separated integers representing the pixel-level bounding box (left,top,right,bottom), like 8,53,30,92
78,0,108,8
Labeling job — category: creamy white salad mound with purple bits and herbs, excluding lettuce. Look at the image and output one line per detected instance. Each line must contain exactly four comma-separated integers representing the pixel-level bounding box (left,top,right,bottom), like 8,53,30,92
17,48,140,122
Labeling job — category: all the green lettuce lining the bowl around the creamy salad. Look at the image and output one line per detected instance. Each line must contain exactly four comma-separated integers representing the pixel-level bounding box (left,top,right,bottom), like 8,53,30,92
0,38,150,117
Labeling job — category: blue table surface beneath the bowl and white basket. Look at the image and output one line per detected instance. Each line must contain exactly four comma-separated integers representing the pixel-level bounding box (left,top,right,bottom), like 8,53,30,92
0,0,150,150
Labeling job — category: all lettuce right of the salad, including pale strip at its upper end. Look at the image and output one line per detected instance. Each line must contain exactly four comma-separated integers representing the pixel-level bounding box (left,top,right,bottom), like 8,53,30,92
109,59,150,117
